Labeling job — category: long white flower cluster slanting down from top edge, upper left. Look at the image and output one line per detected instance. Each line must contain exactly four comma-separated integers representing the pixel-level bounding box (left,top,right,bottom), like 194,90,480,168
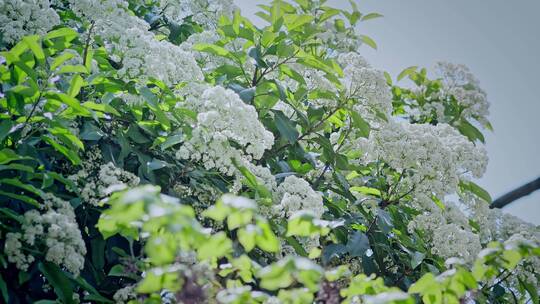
70,0,203,86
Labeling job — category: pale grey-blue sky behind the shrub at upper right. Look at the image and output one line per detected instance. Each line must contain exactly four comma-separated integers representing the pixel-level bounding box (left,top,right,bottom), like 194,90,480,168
235,0,540,224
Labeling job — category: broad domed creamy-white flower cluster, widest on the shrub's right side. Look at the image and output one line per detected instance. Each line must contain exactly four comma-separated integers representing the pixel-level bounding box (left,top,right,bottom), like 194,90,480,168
365,121,487,197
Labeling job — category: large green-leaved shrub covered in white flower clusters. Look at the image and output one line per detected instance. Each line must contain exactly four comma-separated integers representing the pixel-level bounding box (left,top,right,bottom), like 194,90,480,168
0,0,540,304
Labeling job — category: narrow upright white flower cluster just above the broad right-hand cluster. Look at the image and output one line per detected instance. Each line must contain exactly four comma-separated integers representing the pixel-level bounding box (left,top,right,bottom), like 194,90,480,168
338,52,392,119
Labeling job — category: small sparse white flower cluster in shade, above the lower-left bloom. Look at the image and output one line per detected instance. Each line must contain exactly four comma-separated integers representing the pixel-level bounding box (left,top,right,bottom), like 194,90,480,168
68,162,140,206
